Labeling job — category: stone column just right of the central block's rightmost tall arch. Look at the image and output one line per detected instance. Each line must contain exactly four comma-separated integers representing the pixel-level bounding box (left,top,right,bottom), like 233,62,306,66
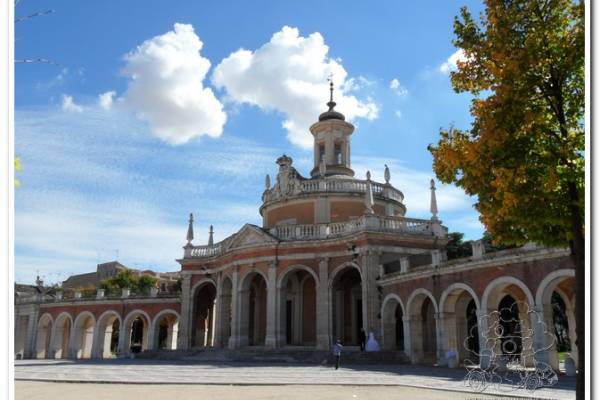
362,250,381,341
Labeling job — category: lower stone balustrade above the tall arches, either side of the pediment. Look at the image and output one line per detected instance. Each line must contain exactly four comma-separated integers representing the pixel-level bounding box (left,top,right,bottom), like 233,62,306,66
184,215,448,258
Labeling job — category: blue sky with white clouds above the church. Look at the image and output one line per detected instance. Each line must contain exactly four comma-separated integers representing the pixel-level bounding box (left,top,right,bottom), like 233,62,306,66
15,0,483,283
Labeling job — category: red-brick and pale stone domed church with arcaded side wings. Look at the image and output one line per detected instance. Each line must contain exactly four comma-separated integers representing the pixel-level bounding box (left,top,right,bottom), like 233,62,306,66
15,90,577,369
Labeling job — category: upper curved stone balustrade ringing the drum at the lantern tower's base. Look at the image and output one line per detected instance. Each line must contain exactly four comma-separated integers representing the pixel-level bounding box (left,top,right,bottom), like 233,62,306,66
264,179,404,203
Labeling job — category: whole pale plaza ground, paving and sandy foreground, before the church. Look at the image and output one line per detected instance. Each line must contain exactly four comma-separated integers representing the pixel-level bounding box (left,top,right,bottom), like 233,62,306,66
15,359,575,400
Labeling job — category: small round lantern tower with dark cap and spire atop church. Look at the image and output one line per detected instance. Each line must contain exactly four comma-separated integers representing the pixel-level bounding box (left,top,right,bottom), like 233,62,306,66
310,81,354,178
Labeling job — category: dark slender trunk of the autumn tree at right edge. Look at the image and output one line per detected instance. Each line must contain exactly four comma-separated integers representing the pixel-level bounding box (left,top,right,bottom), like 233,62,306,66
569,182,585,400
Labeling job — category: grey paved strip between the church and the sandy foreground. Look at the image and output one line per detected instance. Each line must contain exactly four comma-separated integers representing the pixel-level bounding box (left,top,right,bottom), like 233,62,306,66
15,359,575,400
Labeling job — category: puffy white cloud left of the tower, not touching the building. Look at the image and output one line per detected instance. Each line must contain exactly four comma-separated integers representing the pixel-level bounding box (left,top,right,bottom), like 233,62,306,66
122,24,227,144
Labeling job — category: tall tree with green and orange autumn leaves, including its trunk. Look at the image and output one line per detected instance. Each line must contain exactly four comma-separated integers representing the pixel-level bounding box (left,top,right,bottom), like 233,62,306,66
429,0,585,399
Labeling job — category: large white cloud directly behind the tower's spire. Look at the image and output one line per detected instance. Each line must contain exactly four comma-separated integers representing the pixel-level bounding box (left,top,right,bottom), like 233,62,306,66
212,26,378,148
